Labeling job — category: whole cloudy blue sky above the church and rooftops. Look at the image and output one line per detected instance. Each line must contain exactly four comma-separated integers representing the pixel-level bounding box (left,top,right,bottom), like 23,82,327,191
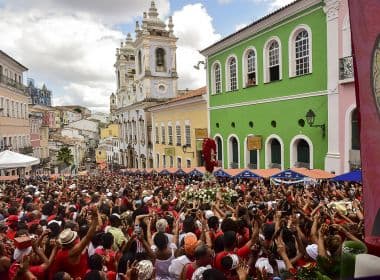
0,0,292,112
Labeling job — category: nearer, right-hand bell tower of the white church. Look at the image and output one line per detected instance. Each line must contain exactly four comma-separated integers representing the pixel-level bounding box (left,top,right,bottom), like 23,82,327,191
134,1,178,101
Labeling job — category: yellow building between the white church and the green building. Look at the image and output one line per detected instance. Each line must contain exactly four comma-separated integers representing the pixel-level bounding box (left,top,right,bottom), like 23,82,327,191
148,87,208,168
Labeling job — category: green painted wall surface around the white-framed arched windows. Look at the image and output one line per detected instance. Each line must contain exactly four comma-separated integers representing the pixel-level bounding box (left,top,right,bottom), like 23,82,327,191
208,6,328,169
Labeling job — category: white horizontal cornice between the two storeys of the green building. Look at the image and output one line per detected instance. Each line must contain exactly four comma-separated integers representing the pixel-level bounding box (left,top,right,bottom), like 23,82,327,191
208,90,334,110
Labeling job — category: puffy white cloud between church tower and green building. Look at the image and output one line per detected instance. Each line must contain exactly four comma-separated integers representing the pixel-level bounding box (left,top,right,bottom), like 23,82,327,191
173,3,221,89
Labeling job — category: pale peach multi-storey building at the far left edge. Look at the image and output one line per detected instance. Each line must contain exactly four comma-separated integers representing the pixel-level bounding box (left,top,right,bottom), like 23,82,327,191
0,51,31,163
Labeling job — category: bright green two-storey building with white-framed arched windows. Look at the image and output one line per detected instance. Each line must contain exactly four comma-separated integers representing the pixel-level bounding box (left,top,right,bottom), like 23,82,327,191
201,0,328,169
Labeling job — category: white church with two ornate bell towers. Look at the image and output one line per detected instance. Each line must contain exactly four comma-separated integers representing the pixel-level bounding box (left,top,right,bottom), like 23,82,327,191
110,1,178,168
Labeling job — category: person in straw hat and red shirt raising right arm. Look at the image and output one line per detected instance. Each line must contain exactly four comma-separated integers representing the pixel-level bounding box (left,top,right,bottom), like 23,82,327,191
49,207,99,279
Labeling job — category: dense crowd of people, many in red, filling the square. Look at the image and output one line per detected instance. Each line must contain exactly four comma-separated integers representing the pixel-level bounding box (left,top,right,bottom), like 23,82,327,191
0,172,363,280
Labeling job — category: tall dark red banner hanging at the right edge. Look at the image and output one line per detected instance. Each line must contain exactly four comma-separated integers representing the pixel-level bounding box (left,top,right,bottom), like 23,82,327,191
349,0,380,249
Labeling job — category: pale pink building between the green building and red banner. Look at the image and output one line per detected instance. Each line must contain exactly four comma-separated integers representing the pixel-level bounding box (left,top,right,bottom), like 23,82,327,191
325,0,360,174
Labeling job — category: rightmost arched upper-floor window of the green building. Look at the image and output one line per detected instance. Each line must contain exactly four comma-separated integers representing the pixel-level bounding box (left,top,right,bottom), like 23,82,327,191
295,30,309,76
